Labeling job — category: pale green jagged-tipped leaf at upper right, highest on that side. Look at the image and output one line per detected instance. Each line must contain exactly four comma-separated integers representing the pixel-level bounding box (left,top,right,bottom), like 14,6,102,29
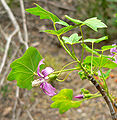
83,17,107,32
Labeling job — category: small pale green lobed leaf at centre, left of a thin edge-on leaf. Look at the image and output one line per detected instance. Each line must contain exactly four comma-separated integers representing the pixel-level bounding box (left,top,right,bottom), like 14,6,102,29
62,33,82,45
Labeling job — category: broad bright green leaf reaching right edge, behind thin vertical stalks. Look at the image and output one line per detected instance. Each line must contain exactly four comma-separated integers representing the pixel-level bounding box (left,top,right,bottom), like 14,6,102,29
84,56,117,69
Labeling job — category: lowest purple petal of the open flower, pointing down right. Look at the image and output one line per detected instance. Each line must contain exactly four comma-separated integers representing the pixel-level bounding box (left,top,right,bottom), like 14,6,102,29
40,82,56,96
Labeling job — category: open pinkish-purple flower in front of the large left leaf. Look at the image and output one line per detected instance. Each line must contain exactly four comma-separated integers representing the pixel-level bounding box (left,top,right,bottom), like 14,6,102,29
32,59,56,96
